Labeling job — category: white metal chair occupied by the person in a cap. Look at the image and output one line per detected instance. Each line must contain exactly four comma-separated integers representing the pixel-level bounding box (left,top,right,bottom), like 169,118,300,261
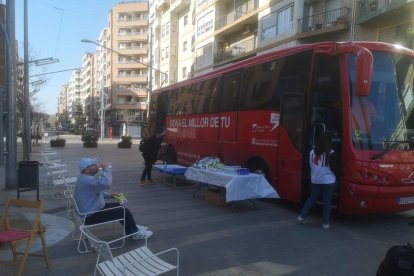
66,191,125,253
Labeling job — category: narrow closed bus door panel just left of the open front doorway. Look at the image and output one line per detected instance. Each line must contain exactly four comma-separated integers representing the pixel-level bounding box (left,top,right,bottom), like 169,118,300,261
277,93,305,202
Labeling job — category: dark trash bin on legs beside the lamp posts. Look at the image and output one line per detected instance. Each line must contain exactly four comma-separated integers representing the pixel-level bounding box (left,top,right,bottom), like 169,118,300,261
17,161,39,200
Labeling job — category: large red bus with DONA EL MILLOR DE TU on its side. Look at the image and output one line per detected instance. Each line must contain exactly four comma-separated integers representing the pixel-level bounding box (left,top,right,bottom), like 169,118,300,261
148,42,414,214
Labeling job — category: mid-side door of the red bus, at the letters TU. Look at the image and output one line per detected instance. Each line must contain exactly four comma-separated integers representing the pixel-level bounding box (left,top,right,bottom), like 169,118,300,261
215,71,241,162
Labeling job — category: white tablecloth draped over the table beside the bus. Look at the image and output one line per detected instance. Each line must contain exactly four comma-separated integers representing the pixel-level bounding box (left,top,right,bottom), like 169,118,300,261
185,167,279,202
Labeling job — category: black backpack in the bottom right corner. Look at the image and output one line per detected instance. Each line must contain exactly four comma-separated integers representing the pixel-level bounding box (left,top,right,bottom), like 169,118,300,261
376,243,414,276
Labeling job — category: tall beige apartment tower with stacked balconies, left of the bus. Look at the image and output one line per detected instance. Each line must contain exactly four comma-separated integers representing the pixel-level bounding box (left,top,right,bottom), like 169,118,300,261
104,1,148,135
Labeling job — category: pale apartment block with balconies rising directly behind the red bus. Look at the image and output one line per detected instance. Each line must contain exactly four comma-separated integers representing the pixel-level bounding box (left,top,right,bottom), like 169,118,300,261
150,0,414,85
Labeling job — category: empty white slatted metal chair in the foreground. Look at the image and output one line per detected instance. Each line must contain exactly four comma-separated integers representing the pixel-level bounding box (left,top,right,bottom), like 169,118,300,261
80,225,180,275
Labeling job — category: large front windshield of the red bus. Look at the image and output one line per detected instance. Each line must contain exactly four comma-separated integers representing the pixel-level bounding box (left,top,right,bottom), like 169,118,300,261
349,52,414,151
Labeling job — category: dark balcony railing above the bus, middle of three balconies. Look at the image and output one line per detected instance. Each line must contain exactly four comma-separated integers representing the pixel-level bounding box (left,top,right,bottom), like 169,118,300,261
298,8,350,34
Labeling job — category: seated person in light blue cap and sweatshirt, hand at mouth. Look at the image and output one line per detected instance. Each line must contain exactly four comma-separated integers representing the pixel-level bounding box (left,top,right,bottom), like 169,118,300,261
75,158,153,240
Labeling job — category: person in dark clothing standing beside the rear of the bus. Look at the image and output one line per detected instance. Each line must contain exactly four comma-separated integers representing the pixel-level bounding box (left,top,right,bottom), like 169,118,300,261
141,132,162,185
